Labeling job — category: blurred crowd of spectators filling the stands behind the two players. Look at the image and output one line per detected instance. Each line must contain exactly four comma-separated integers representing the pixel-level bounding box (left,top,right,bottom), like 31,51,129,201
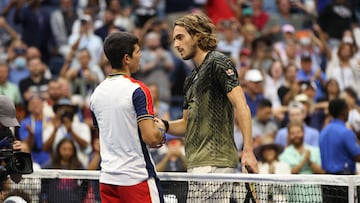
0,0,360,201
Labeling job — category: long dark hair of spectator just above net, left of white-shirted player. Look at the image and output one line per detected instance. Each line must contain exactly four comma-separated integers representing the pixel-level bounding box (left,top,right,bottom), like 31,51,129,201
52,137,83,170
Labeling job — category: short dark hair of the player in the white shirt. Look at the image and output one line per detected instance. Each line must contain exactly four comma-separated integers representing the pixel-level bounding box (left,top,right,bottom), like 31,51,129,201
104,32,139,69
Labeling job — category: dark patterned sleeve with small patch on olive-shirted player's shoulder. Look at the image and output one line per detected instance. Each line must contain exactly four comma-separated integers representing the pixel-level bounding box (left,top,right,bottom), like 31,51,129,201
212,57,240,94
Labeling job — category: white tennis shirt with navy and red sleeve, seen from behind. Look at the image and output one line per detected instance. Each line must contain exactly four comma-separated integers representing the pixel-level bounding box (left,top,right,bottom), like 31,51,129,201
90,74,156,186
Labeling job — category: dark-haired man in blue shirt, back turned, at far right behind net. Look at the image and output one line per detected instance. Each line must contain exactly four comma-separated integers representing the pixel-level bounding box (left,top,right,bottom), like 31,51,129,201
319,98,360,202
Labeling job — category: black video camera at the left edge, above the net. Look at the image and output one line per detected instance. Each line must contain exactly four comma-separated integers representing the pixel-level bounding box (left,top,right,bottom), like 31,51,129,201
0,128,33,181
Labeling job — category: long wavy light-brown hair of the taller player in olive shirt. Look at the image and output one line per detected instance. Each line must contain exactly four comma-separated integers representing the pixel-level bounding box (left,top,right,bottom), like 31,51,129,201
174,13,218,51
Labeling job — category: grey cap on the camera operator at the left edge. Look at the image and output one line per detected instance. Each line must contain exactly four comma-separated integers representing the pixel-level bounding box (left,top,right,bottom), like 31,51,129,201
0,95,20,127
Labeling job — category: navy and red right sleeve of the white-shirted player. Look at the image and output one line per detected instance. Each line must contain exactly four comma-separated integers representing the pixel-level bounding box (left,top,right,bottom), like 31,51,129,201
133,85,154,122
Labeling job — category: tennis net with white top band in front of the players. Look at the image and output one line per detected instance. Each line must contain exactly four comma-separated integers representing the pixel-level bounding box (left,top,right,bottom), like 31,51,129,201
2,170,360,203
